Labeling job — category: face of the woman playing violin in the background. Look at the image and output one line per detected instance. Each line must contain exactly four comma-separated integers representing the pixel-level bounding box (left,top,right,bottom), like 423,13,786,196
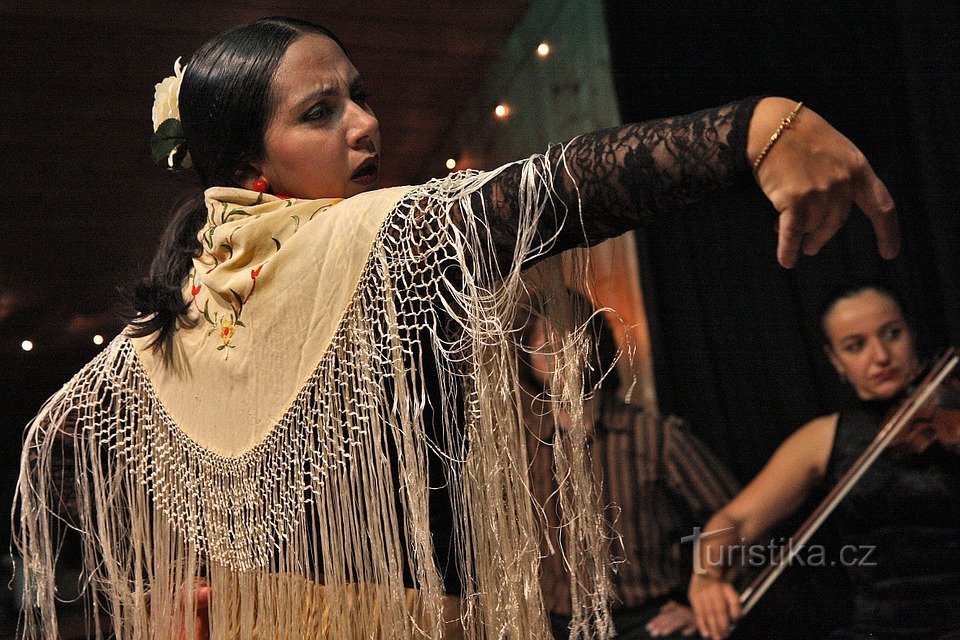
824,289,920,400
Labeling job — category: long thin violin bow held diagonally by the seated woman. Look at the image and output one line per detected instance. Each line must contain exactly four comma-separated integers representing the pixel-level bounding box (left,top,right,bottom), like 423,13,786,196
740,347,960,615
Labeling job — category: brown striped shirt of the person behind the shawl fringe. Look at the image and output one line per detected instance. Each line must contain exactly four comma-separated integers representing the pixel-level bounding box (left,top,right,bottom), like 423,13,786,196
526,397,738,615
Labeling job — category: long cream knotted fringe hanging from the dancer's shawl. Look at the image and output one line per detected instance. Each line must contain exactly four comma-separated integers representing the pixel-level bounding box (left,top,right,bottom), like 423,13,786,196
14,149,611,640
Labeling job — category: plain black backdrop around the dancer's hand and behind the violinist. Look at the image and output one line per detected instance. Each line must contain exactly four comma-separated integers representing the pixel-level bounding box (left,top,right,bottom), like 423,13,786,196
606,0,960,639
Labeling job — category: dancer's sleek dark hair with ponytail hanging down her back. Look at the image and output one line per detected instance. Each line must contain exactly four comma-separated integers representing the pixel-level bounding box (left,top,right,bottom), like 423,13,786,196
127,17,346,356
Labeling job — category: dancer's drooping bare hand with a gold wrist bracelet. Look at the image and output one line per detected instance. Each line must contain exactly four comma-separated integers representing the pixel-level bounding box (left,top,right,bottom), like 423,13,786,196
747,98,900,267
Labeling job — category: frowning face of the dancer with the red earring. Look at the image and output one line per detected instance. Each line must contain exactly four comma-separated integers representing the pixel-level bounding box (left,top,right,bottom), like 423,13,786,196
251,34,380,198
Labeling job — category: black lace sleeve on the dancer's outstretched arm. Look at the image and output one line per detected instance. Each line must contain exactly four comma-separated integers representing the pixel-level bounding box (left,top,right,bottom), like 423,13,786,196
483,97,760,265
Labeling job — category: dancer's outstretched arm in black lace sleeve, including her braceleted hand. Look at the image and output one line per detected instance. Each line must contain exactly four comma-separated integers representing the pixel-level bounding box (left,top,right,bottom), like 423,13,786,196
485,98,899,267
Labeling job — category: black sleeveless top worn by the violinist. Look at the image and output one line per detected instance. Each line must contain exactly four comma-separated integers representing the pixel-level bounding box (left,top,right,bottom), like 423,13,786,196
826,401,960,640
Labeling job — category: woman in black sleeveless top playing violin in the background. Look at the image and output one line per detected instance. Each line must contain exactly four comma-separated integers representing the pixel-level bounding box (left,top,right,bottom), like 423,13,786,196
689,284,960,640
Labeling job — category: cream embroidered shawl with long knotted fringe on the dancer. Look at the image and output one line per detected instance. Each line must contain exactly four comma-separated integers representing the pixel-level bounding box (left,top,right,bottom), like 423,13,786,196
18,157,610,640
